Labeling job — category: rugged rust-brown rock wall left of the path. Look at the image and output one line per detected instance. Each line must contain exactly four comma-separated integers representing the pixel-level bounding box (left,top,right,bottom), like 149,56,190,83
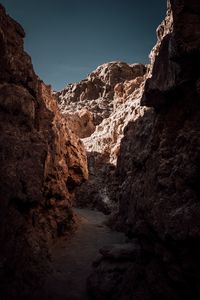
0,5,87,300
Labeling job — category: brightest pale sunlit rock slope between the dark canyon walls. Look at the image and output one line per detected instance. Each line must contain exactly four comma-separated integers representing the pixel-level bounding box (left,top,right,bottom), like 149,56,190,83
83,75,145,165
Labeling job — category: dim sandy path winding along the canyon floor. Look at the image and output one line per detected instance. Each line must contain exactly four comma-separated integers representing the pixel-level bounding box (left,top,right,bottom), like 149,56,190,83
45,209,124,300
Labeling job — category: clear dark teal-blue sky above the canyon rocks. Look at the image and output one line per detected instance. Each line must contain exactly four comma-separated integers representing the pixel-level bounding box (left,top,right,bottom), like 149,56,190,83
0,0,166,90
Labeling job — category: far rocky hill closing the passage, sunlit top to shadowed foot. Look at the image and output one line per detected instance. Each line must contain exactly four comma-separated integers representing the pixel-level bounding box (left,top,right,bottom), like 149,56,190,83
57,62,147,213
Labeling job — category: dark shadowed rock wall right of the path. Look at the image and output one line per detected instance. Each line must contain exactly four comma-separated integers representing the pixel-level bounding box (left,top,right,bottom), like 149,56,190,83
118,1,200,244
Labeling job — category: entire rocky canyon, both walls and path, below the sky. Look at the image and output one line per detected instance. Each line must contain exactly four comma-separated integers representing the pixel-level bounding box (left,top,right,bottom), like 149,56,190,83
0,0,200,300
